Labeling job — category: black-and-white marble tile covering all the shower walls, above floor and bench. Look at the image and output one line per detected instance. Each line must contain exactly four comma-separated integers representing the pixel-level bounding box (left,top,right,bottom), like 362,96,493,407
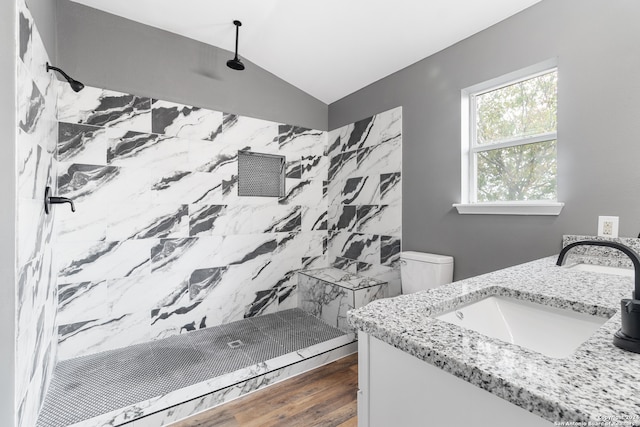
11,1,402,426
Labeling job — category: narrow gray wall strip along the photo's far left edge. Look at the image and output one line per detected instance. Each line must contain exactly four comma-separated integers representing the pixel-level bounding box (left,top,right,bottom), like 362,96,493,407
0,1,16,426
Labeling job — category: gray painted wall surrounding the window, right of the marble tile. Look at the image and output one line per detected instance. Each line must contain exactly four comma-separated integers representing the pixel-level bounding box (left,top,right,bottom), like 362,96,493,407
329,0,640,279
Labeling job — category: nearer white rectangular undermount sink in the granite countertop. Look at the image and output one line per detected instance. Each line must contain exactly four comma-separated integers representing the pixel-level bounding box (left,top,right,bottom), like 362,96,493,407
435,296,608,358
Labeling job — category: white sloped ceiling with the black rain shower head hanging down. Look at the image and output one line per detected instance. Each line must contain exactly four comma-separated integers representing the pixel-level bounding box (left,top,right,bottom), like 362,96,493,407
73,0,540,104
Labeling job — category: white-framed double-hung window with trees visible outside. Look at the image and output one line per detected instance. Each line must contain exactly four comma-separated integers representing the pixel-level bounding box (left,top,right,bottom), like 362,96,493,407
455,61,562,215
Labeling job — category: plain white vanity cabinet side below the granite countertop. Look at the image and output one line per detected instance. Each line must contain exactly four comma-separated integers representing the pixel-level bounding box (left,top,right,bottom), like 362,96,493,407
358,332,554,427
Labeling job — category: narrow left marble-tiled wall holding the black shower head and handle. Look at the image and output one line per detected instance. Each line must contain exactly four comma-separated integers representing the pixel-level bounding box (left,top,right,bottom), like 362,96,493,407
15,0,58,427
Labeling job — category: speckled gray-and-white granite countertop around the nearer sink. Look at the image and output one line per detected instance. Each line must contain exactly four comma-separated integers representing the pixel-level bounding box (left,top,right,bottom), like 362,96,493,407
348,256,640,425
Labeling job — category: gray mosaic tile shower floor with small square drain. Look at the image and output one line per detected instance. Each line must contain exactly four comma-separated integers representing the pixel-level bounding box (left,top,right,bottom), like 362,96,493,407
38,309,344,427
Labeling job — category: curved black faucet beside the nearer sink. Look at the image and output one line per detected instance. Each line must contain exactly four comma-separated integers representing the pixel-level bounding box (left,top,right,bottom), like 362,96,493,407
556,240,640,353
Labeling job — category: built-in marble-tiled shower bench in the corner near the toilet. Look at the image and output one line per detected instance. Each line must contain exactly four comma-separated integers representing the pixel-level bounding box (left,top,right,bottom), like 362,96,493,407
298,267,389,332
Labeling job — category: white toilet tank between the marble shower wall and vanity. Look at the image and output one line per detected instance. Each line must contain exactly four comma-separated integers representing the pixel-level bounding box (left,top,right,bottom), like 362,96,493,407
400,251,453,294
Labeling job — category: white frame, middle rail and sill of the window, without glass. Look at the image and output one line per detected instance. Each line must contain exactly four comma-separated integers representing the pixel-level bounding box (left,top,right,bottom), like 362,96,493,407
453,58,564,215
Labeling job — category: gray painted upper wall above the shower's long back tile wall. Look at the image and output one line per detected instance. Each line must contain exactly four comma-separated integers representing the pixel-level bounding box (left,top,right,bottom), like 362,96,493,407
57,0,328,130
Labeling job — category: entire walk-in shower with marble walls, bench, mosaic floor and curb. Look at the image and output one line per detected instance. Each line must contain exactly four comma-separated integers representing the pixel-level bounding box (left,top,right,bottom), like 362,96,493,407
14,0,401,427
